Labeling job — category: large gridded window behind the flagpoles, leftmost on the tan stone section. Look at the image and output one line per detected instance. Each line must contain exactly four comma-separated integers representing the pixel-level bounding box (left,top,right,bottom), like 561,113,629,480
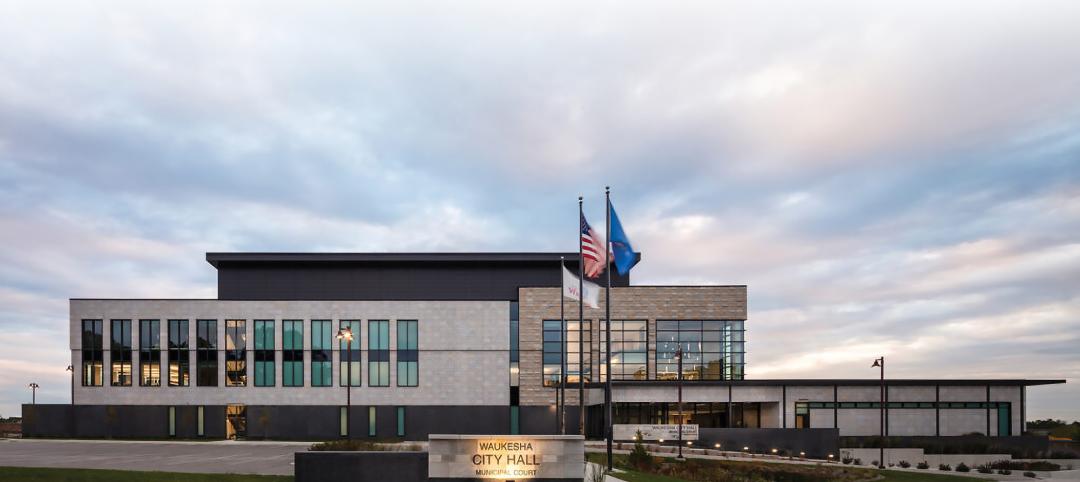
540,320,591,387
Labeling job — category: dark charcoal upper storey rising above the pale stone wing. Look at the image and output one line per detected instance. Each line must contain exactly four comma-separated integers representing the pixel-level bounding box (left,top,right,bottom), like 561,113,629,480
206,253,630,300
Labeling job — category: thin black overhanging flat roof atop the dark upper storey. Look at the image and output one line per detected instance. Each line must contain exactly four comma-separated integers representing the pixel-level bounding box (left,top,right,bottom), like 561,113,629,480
206,252,587,268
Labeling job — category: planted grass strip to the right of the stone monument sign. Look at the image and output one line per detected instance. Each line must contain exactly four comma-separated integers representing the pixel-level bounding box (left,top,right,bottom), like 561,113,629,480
589,454,980,482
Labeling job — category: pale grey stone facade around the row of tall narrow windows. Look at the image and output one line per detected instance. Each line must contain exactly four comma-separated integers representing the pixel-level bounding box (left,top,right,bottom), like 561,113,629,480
70,299,510,405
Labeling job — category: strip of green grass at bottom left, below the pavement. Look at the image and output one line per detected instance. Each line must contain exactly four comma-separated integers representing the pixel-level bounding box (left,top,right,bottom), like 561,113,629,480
0,467,293,482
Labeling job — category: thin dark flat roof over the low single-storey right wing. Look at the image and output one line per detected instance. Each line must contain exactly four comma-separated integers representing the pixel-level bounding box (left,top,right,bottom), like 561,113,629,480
600,378,1065,387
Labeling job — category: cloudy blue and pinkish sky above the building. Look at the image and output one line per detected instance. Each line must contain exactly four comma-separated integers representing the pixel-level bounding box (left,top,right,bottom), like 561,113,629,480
0,1,1080,419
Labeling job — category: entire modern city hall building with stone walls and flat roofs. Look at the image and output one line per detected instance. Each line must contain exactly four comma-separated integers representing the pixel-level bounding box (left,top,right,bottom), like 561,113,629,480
23,253,1064,453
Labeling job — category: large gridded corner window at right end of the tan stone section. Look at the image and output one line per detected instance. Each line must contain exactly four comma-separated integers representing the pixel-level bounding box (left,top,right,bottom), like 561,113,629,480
657,320,743,380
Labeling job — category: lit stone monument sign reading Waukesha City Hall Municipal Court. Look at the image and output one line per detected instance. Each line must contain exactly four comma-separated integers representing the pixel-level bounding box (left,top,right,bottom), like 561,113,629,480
428,434,585,481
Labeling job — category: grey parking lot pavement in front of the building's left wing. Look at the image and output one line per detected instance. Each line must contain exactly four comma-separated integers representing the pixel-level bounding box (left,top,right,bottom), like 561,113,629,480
0,439,309,476
